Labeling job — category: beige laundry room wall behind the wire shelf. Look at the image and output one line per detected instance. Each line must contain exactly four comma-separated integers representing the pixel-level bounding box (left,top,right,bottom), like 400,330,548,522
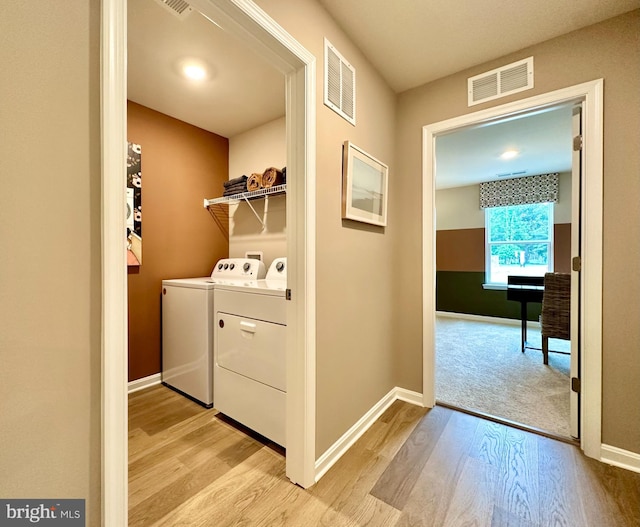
229,117,287,268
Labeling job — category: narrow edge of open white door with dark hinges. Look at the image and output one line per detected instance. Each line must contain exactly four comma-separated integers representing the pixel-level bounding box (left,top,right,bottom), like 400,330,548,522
569,103,583,438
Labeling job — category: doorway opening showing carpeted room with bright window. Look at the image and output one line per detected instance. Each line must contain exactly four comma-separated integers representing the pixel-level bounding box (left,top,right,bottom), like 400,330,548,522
435,102,580,439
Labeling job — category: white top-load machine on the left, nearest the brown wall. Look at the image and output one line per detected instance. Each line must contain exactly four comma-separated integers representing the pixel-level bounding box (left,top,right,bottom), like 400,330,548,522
162,258,265,408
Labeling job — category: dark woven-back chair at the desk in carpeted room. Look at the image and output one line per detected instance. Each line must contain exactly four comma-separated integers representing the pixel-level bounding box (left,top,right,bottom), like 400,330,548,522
541,273,571,364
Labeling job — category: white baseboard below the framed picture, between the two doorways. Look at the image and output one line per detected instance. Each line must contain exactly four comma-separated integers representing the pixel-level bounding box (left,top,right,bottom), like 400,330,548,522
316,387,422,481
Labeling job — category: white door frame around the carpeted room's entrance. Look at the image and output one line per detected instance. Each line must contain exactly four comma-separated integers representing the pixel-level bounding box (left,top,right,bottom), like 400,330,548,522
422,79,604,459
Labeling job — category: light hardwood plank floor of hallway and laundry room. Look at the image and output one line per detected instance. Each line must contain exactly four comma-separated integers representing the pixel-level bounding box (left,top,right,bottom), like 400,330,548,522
129,386,640,527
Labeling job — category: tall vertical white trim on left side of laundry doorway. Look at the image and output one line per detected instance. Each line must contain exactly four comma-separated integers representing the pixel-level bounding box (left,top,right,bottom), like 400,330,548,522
100,0,128,527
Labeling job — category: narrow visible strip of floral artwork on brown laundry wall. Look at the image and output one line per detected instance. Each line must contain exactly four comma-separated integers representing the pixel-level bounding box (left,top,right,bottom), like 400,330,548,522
126,143,142,266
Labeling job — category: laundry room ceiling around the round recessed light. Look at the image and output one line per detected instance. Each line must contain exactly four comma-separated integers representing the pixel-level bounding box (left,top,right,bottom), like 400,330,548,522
127,0,285,137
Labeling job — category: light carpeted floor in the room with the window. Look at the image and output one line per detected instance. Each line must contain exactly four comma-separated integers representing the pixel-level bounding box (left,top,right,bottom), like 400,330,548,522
436,316,570,437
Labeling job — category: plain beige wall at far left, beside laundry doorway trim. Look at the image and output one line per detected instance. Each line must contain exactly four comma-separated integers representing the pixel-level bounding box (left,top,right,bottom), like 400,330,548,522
0,0,101,525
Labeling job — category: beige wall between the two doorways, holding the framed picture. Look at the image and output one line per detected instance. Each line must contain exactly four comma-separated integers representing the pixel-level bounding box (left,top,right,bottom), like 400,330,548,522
257,0,400,456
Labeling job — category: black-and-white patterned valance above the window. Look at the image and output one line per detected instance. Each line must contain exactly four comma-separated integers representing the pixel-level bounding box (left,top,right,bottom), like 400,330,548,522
480,172,558,209
